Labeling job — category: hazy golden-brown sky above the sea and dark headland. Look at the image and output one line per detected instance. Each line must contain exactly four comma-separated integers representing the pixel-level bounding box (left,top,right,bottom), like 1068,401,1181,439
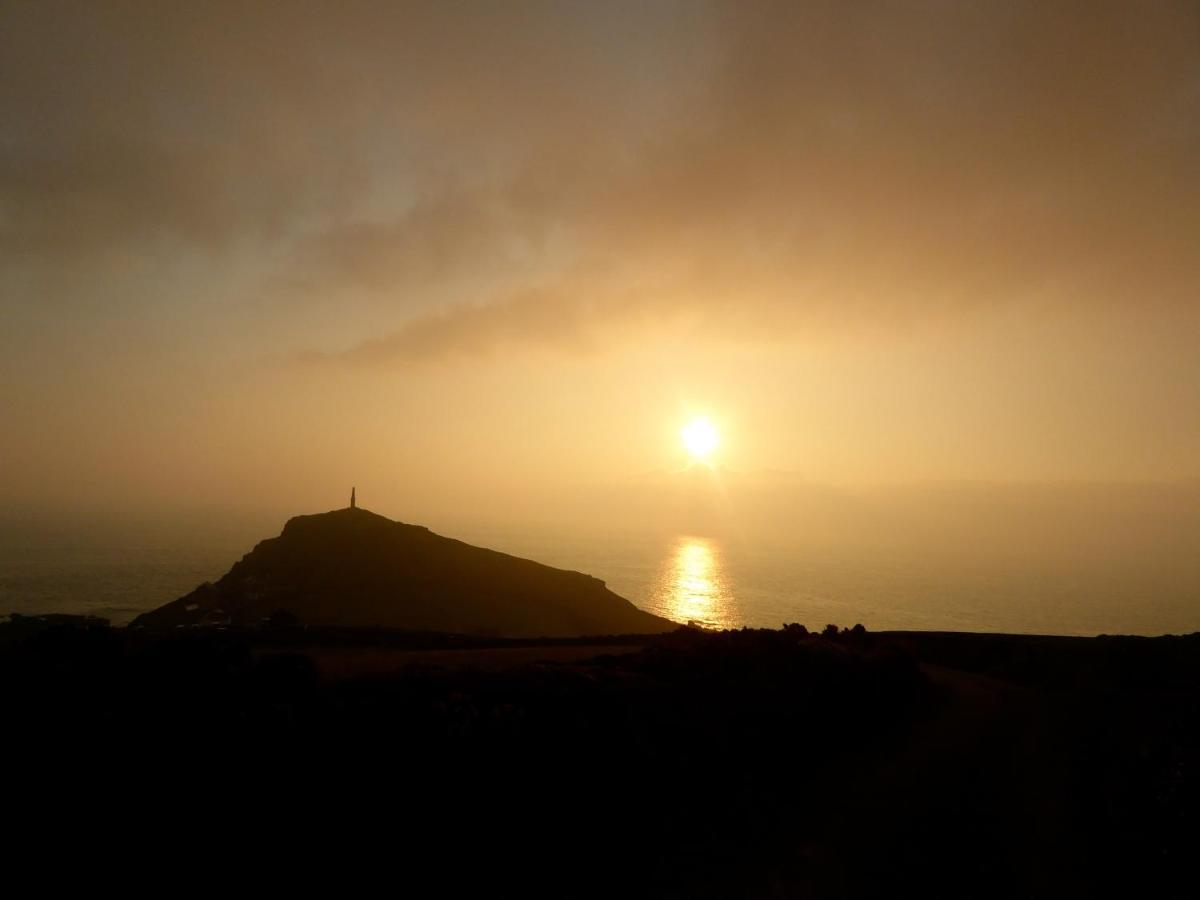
0,0,1200,517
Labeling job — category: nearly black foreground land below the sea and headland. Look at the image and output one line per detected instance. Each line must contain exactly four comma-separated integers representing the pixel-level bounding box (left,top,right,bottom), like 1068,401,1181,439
0,617,1200,898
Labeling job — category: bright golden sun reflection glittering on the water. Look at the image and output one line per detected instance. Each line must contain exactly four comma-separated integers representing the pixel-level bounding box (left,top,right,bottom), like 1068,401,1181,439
655,538,737,628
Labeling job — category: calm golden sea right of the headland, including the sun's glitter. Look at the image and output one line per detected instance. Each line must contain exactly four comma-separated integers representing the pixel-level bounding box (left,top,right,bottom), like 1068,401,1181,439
477,535,1200,635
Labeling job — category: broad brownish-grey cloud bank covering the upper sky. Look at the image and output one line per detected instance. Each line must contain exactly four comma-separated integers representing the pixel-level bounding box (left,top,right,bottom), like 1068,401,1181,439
0,2,1200,355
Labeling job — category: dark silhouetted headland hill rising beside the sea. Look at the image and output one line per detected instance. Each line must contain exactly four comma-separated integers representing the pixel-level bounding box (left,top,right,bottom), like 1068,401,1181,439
132,506,678,637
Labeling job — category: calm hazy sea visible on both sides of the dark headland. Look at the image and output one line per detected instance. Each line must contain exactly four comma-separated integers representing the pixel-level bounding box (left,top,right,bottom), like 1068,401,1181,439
0,518,1200,634
